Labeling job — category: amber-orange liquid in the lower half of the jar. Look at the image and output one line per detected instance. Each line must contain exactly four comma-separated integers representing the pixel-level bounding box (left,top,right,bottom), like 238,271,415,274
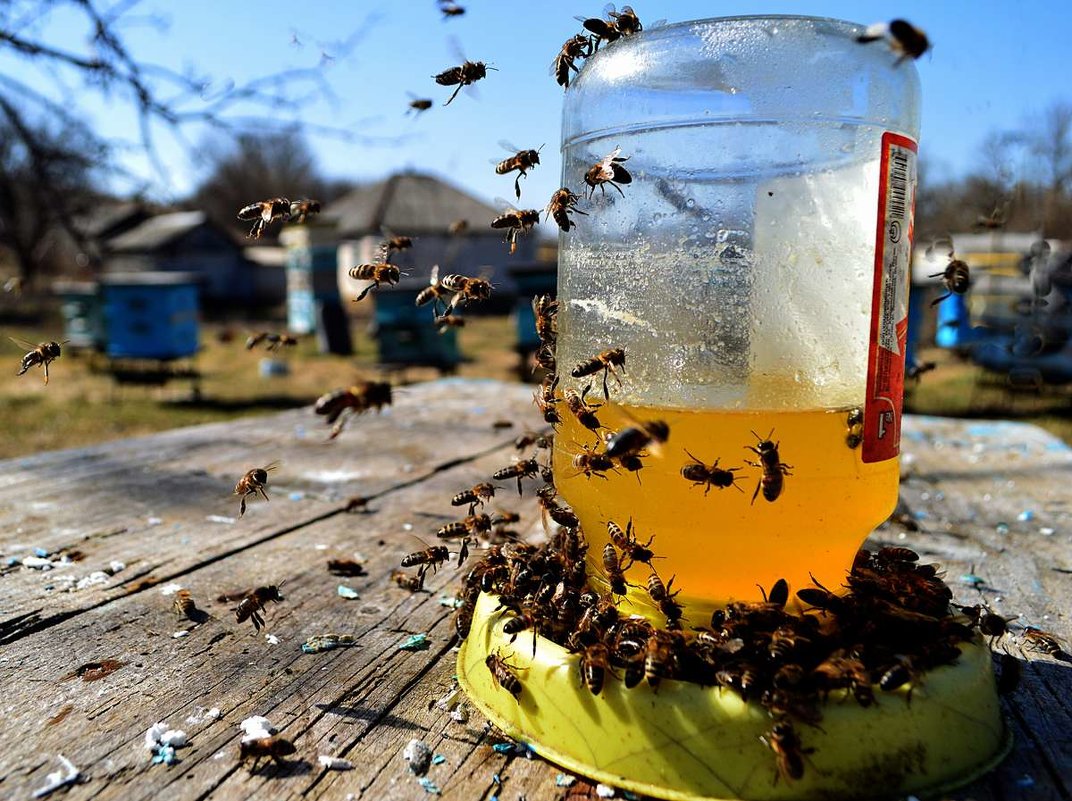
554,403,898,625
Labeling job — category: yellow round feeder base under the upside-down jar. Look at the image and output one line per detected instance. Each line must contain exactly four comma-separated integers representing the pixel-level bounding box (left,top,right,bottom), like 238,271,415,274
458,594,1012,801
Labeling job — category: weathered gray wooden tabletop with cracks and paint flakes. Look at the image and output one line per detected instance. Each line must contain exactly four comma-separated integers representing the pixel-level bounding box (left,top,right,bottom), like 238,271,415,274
0,381,1072,801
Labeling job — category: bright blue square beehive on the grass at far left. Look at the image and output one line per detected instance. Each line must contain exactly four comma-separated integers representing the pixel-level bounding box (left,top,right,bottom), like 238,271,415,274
101,272,199,361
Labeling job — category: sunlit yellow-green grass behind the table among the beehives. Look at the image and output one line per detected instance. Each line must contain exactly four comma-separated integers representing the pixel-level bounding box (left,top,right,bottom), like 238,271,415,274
0,316,1072,458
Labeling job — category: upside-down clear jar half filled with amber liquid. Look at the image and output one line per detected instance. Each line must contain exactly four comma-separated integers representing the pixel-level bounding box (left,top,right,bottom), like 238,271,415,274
554,16,920,605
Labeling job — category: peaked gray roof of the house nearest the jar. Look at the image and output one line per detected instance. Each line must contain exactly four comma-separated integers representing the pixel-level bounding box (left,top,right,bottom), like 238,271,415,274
323,173,502,237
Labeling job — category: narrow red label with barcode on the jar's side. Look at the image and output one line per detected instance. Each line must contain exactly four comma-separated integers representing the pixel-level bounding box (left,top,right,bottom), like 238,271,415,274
862,132,917,462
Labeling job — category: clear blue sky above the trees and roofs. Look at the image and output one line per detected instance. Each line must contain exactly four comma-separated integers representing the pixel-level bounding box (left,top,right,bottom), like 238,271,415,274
8,0,1072,206
